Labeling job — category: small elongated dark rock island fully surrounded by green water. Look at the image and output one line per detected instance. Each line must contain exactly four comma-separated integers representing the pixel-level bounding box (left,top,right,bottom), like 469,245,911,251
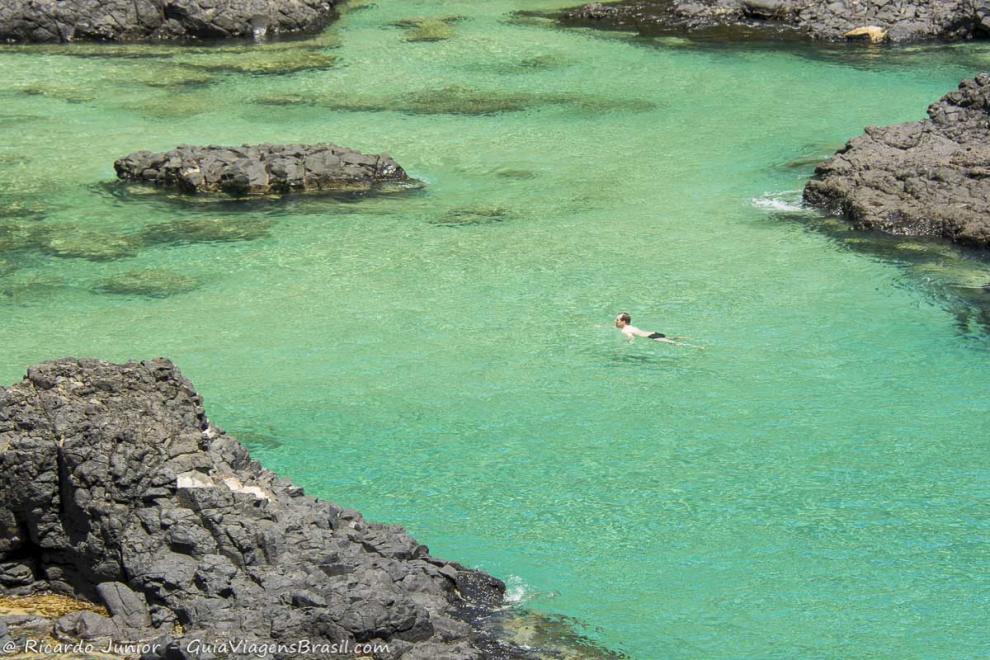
114,144,409,195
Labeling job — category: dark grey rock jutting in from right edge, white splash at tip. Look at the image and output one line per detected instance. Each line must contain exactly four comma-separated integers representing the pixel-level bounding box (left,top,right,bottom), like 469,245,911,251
804,74,990,248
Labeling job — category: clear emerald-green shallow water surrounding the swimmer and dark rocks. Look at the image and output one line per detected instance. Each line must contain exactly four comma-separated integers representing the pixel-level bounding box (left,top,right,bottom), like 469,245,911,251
0,0,990,659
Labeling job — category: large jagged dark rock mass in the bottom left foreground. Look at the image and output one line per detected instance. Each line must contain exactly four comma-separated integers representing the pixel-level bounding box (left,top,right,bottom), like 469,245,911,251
0,359,524,660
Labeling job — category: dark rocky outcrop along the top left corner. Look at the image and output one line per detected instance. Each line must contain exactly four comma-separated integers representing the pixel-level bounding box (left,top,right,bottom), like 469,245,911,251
0,0,336,43
